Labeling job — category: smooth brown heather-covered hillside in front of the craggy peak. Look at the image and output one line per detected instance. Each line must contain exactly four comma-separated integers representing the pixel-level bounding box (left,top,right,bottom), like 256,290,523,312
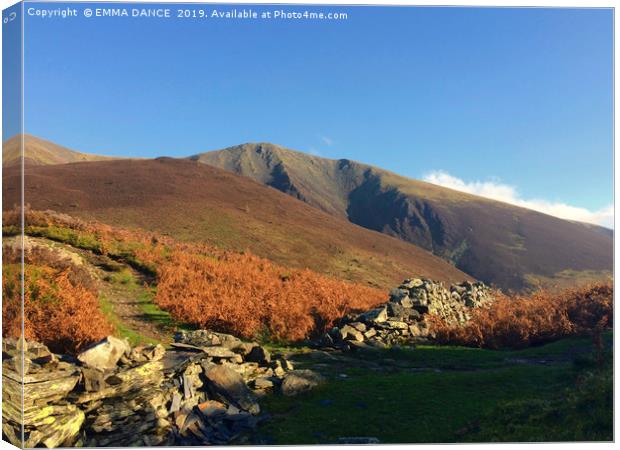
3,158,471,289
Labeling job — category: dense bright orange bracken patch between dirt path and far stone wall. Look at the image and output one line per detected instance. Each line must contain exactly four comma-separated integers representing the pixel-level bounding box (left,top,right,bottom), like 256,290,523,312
155,250,385,340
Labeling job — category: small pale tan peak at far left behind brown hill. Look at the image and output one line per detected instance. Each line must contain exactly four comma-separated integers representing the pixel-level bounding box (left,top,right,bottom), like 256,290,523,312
2,134,118,167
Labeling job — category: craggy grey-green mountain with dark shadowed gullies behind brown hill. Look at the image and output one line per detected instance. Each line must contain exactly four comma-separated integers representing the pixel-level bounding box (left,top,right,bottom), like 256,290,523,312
190,143,613,290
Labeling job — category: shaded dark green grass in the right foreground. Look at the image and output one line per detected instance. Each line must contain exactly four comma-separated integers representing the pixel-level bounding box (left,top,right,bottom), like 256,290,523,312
257,337,611,444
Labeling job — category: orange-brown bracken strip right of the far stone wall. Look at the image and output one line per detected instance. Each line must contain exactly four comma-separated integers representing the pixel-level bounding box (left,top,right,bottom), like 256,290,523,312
430,283,613,349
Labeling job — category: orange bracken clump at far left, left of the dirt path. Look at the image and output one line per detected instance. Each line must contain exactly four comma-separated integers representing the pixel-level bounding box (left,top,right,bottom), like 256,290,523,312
2,246,112,353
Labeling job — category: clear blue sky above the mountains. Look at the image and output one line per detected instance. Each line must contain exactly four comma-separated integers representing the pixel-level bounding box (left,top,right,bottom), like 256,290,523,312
13,3,613,225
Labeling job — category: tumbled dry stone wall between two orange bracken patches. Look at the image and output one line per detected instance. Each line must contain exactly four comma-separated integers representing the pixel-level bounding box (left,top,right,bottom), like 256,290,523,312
320,278,493,350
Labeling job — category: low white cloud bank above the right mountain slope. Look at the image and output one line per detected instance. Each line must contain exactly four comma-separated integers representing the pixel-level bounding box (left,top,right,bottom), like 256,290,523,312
423,170,614,228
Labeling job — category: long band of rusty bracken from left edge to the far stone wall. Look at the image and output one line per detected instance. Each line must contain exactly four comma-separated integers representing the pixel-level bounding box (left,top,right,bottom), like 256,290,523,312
3,209,386,340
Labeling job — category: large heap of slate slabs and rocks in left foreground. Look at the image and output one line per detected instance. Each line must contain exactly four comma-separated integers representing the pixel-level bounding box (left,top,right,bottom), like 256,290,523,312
2,330,303,447
